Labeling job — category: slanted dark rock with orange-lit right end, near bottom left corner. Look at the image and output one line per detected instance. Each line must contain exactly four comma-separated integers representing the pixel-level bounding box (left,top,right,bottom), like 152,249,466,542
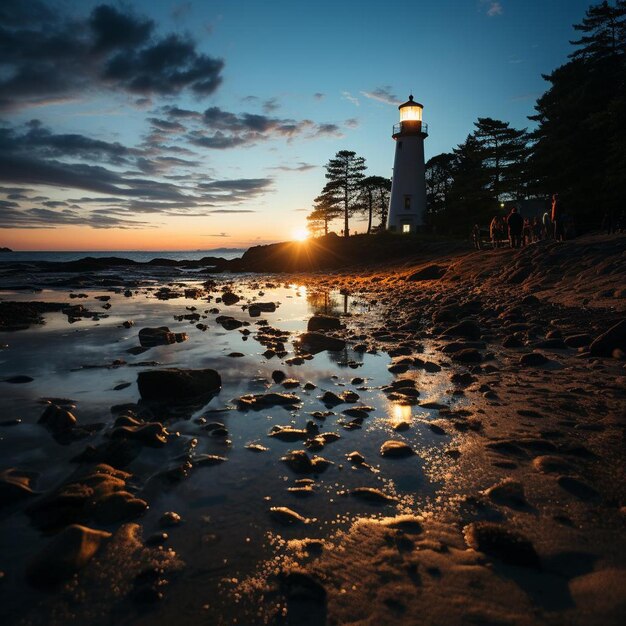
26,524,111,587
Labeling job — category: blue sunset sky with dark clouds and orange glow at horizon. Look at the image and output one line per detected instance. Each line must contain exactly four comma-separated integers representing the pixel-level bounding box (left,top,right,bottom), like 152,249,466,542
0,0,590,250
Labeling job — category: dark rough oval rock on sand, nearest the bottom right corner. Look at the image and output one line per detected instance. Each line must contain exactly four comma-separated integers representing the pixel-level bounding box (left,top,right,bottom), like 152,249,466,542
463,522,540,568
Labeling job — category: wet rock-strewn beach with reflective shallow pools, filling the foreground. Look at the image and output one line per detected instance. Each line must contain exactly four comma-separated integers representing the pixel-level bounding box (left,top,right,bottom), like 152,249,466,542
0,232,626,624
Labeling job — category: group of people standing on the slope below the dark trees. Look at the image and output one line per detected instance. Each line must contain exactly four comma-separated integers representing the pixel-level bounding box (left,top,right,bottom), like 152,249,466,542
472,193,566,250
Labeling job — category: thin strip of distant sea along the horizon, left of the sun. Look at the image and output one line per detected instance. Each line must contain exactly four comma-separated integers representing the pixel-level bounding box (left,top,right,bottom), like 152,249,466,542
0,248,246,263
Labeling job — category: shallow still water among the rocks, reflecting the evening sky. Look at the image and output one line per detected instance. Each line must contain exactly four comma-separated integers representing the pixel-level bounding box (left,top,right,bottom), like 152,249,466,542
0,278,455,623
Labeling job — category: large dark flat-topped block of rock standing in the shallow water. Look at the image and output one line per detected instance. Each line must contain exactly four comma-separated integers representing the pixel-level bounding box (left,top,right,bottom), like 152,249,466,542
137,368,222,402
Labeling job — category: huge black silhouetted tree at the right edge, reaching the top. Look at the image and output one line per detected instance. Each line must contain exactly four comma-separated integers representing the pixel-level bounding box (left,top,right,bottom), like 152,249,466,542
530,0,626,225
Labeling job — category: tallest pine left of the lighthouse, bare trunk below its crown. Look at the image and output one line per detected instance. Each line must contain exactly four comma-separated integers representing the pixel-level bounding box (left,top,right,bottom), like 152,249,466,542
322,150,366,237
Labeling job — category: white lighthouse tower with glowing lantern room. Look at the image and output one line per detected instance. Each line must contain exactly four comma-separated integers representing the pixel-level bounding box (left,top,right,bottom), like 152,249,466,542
387,96,428,234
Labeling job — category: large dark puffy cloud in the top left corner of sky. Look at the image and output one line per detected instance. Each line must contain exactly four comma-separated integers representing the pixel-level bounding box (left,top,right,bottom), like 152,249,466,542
0,0,224,109
